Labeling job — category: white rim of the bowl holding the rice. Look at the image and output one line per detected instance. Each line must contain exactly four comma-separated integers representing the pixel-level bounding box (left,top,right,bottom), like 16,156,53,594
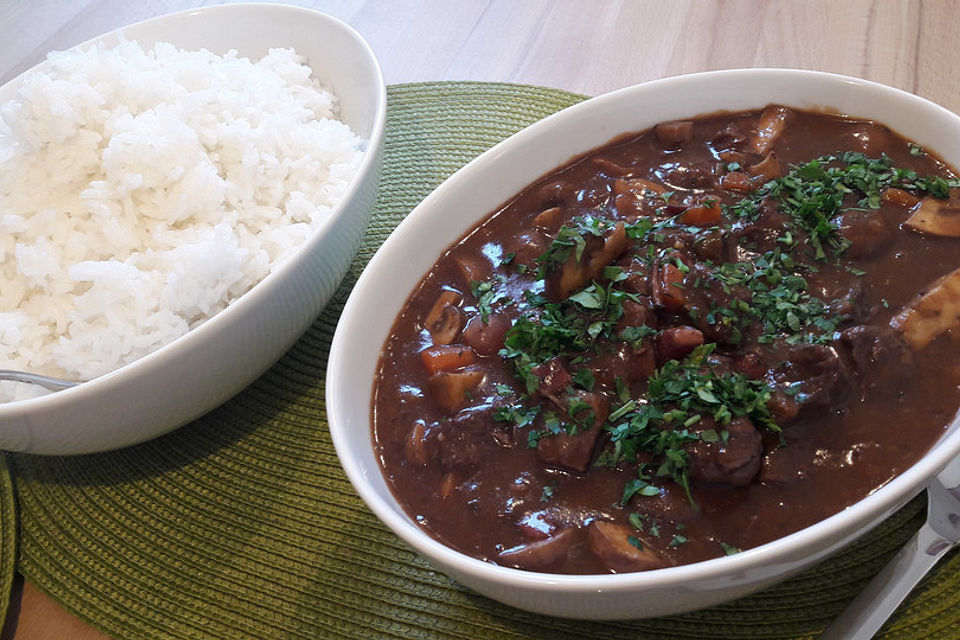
0,3,387,419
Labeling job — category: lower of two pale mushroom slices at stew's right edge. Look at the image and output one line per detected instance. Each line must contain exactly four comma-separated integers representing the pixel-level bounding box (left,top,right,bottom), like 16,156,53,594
890,269,960,350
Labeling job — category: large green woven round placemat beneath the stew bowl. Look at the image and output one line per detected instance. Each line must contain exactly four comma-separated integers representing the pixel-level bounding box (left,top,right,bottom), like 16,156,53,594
3,83,960,640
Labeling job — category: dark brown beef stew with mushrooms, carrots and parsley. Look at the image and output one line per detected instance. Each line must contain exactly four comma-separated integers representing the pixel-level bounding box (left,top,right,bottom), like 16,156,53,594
372,106,960,573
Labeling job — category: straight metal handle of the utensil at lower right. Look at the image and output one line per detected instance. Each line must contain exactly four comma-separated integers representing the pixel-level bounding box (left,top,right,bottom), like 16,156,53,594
820,524,956,640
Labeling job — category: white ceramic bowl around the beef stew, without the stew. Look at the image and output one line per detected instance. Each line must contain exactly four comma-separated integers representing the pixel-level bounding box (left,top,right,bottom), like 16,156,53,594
327,69,960,619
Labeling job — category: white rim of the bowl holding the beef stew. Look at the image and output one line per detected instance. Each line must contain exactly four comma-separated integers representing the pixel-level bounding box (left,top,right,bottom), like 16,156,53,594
326,67,960,593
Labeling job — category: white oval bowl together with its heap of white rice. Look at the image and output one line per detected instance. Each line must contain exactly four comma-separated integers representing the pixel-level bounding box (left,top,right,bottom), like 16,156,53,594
0,4,386,455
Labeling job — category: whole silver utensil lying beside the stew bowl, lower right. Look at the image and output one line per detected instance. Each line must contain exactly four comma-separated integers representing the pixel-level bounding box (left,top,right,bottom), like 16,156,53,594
820,458,960,640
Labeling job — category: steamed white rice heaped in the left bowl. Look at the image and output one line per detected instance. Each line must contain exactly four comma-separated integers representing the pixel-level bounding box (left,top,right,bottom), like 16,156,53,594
0,42,364,401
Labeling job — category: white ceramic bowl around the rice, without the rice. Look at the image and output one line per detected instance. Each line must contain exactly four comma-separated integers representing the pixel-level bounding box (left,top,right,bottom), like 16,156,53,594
0,4,386,454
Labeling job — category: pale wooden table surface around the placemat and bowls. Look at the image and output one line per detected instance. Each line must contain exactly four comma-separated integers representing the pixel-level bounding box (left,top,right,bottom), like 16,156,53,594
0,0,960,640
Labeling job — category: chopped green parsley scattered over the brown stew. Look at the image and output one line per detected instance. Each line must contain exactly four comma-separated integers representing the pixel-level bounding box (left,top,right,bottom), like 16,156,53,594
496,150,958,516
